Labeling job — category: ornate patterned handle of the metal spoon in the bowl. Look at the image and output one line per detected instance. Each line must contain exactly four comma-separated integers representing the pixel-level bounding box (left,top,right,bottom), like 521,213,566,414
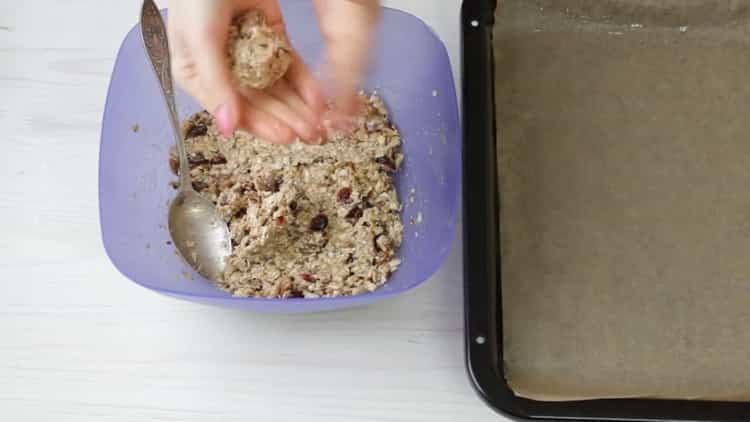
141,0,192,190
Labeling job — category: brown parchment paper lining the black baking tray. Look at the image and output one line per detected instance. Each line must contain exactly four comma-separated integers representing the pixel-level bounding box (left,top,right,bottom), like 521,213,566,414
495,0,750,400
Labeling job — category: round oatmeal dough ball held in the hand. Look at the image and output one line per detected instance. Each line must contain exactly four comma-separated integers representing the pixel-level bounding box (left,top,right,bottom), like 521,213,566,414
228,11,292,89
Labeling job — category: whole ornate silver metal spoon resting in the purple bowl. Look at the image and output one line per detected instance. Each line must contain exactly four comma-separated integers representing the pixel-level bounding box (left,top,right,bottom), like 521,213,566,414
141,0,232,280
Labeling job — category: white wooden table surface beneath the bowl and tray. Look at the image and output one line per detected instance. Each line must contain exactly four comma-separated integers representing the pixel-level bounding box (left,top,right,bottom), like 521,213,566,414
0,0,501,422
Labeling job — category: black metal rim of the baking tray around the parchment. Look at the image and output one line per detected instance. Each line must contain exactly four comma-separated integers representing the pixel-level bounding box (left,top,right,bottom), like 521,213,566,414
461,0,750,422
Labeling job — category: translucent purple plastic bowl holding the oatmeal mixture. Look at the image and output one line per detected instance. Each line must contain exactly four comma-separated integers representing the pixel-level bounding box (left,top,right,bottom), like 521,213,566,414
99,0,461,313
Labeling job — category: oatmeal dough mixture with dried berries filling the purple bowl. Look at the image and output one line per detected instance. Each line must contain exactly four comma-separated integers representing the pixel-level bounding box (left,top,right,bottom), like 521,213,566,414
170,96,403,298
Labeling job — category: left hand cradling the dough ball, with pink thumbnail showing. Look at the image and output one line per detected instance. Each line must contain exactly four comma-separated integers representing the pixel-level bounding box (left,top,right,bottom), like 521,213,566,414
168,0,324,144
